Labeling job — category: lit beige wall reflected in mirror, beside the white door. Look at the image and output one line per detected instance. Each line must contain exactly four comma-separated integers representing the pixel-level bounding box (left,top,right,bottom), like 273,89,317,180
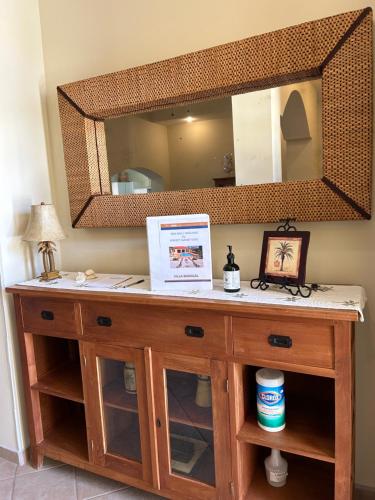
167,118,233,189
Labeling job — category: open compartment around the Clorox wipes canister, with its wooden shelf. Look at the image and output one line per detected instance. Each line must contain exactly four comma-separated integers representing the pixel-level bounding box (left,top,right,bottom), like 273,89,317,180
237,366,335,463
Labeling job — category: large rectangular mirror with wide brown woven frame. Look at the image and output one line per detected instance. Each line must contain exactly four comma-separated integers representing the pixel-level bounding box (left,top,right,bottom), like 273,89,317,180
58,8,373,228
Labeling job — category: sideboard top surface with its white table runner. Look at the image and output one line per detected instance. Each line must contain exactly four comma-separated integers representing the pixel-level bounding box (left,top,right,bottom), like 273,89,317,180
6,272,366,321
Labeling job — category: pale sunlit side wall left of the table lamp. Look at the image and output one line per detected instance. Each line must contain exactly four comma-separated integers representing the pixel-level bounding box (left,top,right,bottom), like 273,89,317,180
0,0,51,458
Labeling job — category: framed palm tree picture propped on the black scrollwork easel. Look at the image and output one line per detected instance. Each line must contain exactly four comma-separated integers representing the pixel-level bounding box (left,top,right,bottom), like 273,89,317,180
259,231,310,286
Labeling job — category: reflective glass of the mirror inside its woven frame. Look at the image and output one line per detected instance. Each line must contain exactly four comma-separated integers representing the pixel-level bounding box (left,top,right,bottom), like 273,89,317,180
105,79,322,194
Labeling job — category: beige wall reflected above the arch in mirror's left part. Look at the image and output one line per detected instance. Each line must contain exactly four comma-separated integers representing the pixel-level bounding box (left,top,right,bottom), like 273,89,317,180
105,116,170,189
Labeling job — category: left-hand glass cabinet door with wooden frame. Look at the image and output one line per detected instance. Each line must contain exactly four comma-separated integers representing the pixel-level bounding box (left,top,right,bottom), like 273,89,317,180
86,344,151,480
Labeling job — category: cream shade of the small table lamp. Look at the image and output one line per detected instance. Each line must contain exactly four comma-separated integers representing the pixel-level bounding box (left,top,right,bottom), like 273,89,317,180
22,203,66,241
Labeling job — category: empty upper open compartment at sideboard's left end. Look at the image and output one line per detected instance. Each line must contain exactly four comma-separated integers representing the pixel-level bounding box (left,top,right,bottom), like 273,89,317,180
31,335,83,403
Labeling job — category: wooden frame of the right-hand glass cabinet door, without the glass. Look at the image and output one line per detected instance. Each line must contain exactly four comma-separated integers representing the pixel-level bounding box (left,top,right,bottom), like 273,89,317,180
152,352,232,499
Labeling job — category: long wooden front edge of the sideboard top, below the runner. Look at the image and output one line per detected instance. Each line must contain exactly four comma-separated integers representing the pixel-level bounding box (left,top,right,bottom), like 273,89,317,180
6,285,359,321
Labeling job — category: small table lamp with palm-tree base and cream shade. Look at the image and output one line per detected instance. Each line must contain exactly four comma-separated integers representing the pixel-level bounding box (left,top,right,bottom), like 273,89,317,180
22,203,66,281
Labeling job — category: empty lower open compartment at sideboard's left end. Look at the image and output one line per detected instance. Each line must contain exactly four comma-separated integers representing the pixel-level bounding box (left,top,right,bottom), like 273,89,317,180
40,394,88,461
